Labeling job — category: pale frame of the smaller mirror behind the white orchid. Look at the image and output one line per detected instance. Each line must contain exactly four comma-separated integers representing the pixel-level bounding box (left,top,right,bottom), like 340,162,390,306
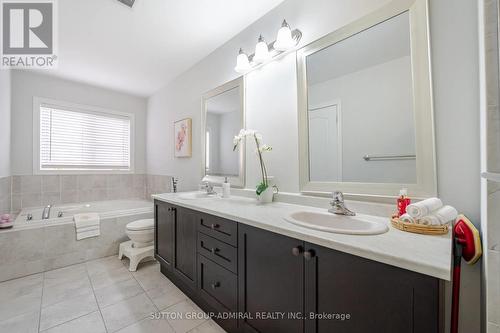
201,76,245,188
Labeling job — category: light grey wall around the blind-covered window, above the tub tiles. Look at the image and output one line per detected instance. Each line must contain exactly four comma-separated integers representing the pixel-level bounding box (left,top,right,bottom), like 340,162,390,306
12,70,147,175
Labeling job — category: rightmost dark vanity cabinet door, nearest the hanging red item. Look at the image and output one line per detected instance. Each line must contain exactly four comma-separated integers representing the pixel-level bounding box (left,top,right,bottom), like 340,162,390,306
305,243,439,333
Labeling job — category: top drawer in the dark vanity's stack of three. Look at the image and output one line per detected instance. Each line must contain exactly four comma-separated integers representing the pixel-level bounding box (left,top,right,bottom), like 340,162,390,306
198,214,238,246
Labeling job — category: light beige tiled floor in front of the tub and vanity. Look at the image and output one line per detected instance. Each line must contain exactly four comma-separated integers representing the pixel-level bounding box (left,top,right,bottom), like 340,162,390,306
0,256,224,333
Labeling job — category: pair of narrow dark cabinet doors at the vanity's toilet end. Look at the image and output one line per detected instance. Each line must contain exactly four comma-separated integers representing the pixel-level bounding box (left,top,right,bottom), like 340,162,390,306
155,201,199,290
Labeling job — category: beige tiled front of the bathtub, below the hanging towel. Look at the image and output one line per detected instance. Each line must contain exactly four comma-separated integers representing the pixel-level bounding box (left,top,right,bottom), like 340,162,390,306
0,211,153,282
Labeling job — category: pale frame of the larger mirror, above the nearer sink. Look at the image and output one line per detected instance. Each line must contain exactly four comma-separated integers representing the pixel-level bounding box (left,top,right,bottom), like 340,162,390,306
297,0,437,198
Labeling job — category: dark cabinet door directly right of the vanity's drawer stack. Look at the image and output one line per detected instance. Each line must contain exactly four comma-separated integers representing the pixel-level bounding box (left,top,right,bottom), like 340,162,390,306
238,225,304,333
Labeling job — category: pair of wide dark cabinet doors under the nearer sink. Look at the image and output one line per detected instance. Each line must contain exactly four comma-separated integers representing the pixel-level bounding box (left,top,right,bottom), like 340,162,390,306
239,225,440,333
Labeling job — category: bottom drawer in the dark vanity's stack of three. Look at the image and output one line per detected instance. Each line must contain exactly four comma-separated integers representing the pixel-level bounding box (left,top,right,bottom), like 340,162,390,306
198,254,238,311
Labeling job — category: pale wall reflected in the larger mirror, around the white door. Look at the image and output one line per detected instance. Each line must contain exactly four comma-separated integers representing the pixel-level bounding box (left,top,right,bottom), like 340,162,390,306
308,57,417,183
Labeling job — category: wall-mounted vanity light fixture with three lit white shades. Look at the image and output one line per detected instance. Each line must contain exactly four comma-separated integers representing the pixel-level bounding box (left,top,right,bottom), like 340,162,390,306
234,20,302,74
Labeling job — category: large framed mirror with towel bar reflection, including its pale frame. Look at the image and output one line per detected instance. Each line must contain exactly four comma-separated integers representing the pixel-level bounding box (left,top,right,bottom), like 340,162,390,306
297,0,437,198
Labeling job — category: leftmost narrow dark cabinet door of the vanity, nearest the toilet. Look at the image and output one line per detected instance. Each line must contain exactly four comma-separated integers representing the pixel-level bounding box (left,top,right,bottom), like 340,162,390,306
155,201,175,270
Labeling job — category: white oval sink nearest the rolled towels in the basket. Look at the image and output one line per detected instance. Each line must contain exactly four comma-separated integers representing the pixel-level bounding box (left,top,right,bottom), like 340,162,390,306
285,211,389,235
